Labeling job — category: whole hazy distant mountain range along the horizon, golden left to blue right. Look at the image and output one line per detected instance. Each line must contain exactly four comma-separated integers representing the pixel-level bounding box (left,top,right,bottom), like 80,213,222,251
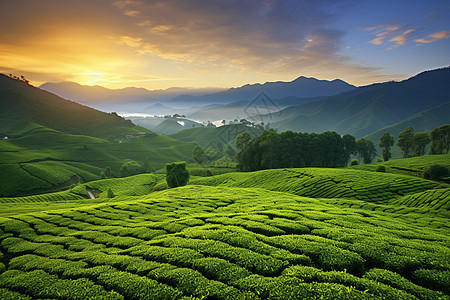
40,76,355,114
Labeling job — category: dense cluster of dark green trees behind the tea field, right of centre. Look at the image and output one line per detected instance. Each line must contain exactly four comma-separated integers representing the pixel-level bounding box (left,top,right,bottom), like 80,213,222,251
236,130,376,171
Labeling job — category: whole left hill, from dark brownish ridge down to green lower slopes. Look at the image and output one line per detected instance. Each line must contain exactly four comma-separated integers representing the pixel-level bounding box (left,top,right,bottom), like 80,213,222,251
0,75,195,196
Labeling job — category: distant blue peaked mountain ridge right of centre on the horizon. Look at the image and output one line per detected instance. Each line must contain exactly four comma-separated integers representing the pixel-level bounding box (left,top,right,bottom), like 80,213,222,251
169,76,355,106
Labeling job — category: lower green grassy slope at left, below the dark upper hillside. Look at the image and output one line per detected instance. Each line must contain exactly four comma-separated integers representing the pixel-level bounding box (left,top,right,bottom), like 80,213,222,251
0,125,194,196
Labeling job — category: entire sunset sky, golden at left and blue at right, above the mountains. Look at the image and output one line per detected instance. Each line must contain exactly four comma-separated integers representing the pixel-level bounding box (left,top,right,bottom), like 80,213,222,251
0,0,450,90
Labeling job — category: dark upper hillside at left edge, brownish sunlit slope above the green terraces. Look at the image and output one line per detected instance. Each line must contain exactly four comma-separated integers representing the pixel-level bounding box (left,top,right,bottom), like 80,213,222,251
0,74,151,139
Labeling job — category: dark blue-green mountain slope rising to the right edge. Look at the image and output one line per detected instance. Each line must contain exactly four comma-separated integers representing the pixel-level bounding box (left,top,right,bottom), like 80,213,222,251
268,68,450,137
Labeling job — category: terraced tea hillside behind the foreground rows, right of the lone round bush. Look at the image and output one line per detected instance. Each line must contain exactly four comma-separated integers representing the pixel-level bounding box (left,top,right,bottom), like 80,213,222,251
190,168,450,213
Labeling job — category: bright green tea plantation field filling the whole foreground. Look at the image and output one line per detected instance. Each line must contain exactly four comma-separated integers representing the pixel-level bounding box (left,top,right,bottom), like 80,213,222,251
0,169,450,299
